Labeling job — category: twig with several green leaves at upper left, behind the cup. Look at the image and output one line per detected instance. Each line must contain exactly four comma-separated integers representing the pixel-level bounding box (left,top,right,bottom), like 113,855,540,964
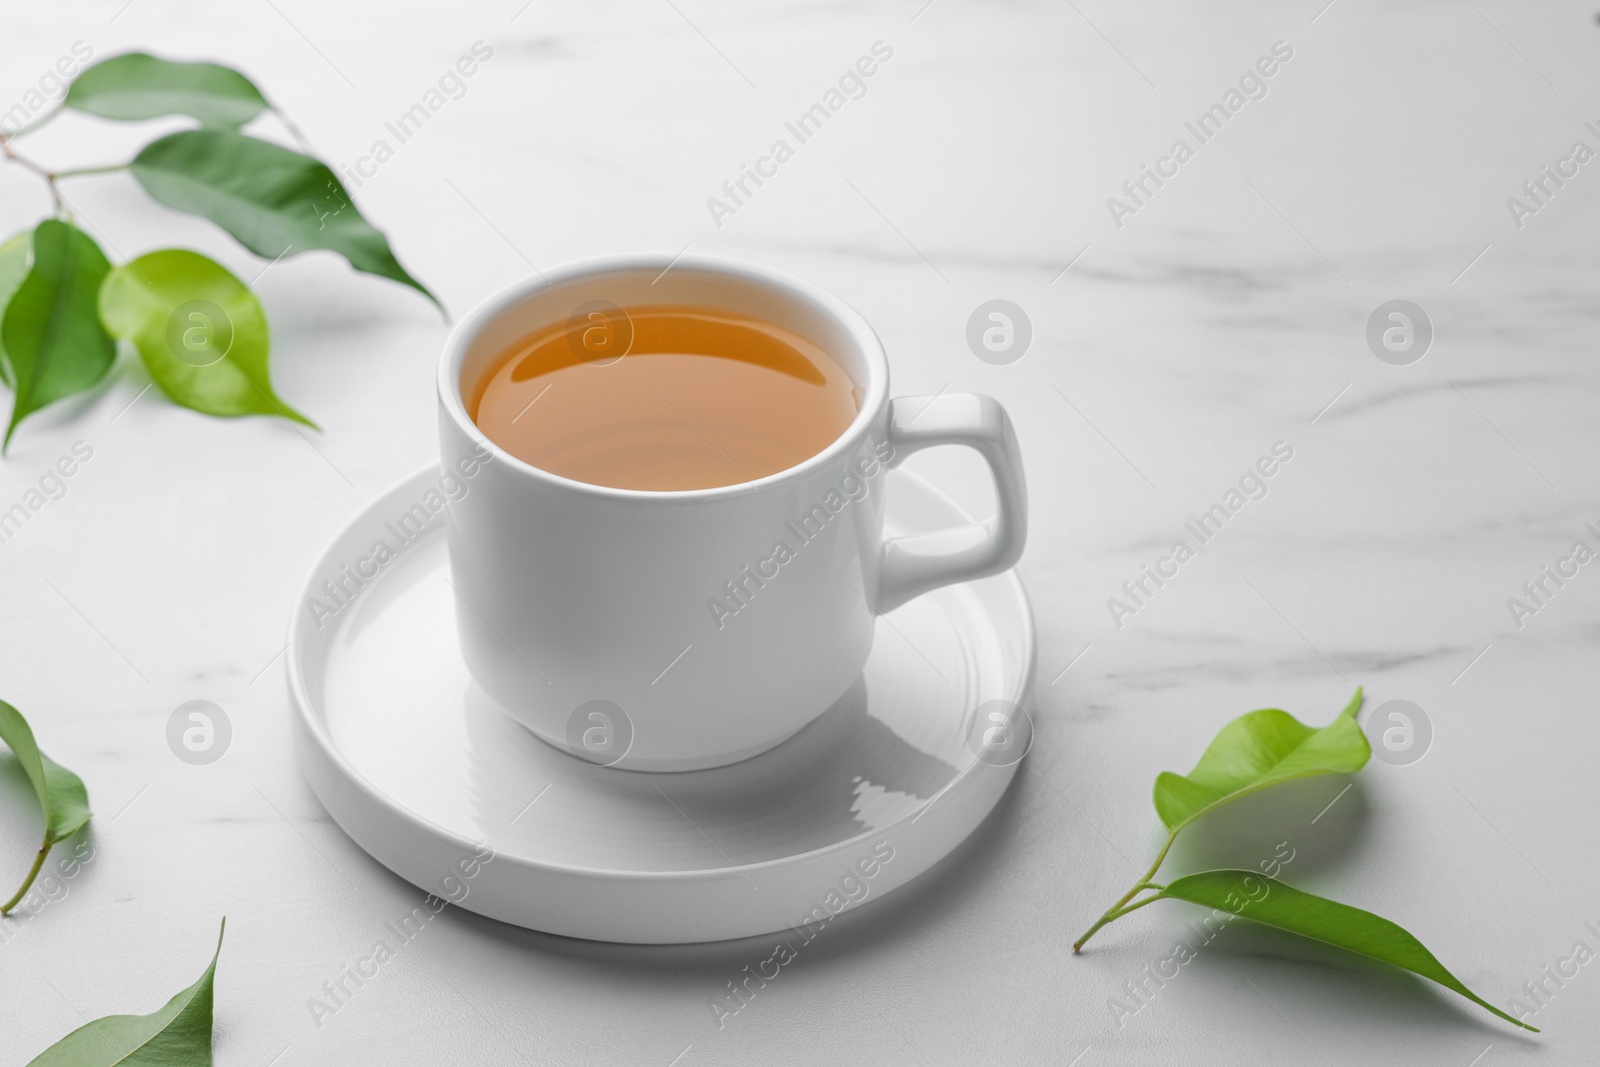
0,53,438,451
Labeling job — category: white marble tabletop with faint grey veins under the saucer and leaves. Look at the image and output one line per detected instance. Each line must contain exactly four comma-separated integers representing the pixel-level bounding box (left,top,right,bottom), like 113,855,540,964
0,0,1600,1067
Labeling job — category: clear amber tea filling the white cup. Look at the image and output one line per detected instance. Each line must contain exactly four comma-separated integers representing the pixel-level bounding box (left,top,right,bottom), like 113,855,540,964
467,306,859,490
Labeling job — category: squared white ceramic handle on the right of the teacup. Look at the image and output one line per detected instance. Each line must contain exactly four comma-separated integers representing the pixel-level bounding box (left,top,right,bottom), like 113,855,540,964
872,394,1027,614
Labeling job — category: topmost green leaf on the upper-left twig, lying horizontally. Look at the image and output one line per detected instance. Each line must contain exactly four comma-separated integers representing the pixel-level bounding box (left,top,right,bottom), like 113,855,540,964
62,51,270,128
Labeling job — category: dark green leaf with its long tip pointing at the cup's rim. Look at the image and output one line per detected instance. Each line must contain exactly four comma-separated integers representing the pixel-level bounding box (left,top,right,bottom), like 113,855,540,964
128,130,438,304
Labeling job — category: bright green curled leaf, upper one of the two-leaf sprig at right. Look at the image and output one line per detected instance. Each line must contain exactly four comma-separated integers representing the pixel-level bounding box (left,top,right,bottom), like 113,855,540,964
1155,689,1373,833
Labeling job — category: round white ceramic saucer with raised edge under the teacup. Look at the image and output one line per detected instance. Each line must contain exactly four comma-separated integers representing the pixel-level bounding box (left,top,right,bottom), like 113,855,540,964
288,467,1034,944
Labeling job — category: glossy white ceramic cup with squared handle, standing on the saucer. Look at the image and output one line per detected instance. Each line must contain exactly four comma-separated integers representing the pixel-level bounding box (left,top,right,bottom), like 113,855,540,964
438,254,1027,771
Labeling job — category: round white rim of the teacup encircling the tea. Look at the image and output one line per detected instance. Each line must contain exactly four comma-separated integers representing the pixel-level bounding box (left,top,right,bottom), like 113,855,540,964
438,253,888,502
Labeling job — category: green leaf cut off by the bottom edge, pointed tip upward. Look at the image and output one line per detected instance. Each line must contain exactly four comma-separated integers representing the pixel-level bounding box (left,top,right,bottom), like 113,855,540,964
27,918,227,1067
